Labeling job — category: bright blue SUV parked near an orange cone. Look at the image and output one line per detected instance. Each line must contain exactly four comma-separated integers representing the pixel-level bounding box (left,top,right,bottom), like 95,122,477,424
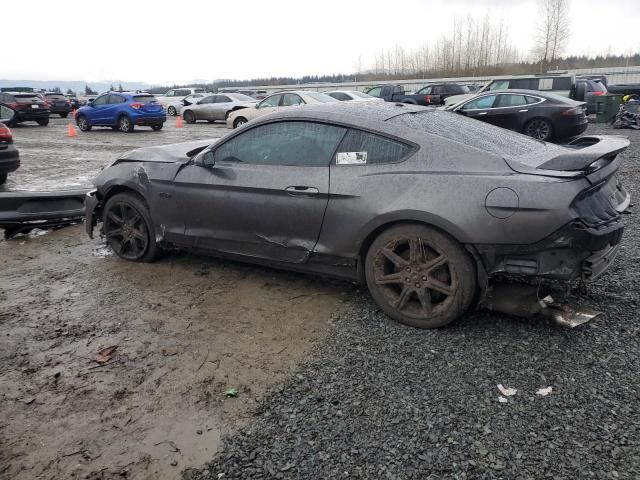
76,92,167,133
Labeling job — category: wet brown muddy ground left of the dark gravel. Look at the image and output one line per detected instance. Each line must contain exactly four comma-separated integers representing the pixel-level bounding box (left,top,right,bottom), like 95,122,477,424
0,119,354,480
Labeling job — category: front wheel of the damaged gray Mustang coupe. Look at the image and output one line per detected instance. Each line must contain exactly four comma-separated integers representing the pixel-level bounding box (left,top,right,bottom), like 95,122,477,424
102,193,160,262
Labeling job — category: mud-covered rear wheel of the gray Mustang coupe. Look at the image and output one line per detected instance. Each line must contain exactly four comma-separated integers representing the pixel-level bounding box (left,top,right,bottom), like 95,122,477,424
365,224,476,328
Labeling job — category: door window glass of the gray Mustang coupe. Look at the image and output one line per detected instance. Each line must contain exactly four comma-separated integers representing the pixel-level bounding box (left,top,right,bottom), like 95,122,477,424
215,122,346,167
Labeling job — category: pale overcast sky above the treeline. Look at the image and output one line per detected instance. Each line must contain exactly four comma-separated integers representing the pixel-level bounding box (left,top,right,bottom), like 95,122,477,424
5,0,640,84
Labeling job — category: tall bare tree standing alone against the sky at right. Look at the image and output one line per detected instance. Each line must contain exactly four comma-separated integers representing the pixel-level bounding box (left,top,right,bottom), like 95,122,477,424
533,0,571,69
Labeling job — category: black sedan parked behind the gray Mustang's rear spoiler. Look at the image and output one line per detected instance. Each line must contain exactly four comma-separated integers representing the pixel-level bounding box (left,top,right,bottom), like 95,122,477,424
448,90,589,141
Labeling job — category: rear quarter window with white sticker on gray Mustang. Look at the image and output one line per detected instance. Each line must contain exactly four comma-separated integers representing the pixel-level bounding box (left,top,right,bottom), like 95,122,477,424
336,130,414,165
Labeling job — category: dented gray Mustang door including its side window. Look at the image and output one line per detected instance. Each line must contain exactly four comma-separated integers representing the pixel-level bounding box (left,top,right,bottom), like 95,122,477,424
174,121,346,263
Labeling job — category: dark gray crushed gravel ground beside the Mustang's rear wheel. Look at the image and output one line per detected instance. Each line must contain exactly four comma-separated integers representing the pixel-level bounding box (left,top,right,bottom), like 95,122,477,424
183,126,640,480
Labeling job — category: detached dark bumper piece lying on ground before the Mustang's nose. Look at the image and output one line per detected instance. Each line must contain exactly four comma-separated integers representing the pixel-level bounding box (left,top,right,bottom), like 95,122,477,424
0,190,87,238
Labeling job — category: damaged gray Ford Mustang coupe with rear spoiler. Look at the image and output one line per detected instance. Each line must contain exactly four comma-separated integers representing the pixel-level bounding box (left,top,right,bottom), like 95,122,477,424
86,102,630,328
